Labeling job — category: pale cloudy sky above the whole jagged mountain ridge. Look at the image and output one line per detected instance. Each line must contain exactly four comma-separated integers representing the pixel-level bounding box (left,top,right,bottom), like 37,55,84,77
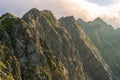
0,0,120,28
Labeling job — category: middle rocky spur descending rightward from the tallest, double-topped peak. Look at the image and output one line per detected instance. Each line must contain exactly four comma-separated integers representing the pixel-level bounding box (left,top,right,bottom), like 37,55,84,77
23,9,86,80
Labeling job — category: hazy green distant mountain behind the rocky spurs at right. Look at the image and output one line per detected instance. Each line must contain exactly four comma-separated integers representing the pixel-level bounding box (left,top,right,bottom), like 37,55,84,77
77,18,120,80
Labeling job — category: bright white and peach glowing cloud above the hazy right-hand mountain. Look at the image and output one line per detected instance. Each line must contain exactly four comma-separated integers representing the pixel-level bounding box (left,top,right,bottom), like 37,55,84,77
58,0,120,28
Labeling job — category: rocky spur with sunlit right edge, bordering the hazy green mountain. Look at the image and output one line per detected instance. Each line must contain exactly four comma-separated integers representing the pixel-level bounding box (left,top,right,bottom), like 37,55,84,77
60,16,110,80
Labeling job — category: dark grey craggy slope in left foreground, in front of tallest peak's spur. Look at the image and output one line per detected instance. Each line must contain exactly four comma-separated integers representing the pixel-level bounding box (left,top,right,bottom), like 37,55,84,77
0,14,68,80
